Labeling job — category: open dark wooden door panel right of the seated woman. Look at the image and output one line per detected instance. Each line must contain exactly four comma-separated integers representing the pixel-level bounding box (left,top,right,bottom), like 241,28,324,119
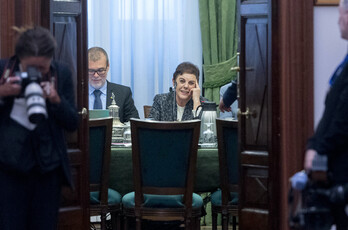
239,0,273,230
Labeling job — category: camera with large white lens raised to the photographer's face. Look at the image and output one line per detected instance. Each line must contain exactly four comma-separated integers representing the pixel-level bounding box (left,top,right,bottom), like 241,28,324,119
16,66,47,124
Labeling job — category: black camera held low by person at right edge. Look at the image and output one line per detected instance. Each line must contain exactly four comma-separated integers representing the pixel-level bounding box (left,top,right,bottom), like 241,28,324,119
288,154,348,230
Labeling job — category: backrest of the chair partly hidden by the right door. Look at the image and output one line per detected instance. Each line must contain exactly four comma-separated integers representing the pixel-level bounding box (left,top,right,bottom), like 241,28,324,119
216,119,239,204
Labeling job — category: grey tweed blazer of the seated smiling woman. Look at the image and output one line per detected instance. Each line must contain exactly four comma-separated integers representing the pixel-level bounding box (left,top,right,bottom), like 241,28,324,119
149,91,207,121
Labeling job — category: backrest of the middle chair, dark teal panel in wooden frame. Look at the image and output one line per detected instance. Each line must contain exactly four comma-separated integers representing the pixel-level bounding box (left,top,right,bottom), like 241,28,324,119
131,119,200,207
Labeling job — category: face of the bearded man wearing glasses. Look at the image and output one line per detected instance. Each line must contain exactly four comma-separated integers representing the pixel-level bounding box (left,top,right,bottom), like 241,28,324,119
88,55,109,89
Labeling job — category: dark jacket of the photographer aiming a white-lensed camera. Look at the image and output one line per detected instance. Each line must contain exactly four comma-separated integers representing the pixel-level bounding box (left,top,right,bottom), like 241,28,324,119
0,57,78,186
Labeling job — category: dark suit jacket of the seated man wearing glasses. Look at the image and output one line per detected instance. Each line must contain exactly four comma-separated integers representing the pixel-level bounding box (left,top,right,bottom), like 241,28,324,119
106,81,139,123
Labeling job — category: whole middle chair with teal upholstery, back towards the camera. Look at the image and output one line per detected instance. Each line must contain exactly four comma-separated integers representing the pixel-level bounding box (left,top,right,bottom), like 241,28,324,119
122,119,203,230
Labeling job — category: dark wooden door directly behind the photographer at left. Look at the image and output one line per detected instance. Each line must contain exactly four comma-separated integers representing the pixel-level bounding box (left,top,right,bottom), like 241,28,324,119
42,0,89,230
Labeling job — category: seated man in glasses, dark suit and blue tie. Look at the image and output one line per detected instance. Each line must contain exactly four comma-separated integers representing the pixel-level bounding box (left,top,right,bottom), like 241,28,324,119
88,47,139,123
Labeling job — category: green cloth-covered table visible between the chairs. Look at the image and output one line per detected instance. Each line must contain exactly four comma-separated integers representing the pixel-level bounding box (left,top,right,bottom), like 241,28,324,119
109,147,220,195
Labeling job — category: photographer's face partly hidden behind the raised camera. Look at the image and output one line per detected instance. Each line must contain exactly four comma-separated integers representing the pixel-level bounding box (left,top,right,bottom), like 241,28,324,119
20,56,52,75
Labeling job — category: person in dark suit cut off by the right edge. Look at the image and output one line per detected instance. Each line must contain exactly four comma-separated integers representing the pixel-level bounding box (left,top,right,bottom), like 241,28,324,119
304,0,348,230
